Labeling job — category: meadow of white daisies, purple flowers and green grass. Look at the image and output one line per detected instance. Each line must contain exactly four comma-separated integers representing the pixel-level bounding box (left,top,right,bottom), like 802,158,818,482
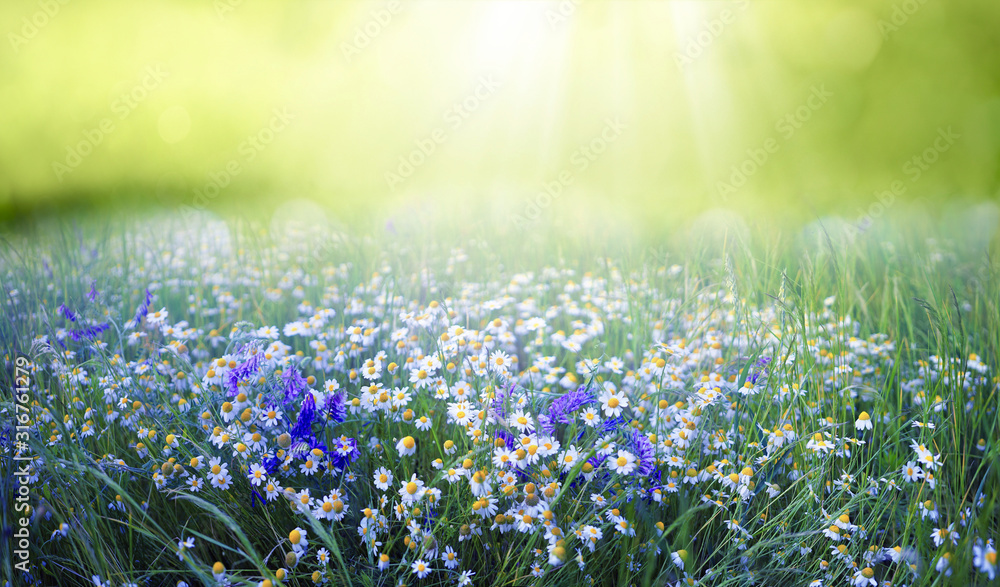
0,219,1000,587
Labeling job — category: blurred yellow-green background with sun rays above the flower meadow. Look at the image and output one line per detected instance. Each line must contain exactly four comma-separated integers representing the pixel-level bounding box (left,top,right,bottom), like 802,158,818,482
0,0,1000,232
